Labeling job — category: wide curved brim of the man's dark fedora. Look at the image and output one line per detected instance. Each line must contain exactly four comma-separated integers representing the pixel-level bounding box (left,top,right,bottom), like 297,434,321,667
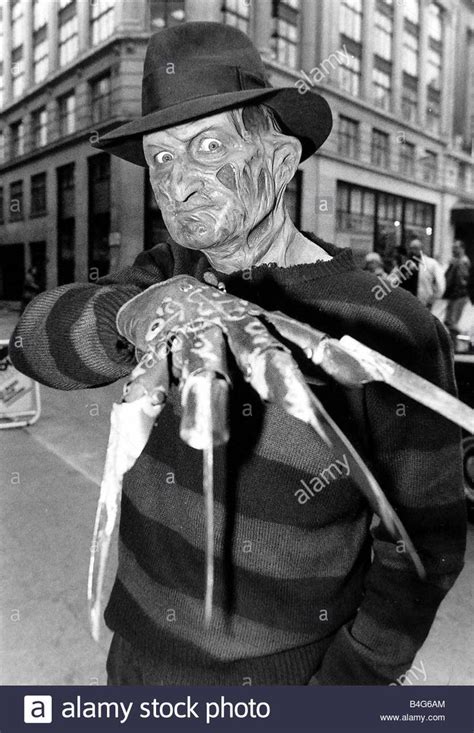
91,87,332,168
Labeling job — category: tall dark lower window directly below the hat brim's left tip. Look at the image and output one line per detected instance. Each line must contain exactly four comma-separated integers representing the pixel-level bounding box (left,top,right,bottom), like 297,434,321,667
89,153,110,276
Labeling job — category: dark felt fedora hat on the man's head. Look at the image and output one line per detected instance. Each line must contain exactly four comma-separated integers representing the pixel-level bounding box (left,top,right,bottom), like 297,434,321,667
93,22,332,167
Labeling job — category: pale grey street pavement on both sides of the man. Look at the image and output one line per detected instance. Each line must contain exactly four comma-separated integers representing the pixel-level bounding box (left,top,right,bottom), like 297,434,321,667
0,304,474,685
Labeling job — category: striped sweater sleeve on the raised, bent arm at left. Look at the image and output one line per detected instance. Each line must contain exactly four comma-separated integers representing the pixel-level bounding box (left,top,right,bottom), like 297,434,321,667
9,244,172,389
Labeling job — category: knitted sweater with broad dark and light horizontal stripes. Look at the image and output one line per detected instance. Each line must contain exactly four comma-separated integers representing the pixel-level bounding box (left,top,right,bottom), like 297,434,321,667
10,234,466,685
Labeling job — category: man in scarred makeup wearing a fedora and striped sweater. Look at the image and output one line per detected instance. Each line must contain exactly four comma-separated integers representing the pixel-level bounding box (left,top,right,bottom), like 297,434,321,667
10,23,465,685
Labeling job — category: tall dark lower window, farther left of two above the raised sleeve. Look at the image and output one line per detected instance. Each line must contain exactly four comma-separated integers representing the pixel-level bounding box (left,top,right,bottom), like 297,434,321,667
57,163,76,285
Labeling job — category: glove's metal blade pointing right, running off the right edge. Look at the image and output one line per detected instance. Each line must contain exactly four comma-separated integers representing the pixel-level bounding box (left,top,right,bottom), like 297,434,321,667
339,336,474,433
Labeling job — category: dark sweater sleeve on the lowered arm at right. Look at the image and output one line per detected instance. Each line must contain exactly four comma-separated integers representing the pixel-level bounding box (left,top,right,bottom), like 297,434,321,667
315,319,466,685
